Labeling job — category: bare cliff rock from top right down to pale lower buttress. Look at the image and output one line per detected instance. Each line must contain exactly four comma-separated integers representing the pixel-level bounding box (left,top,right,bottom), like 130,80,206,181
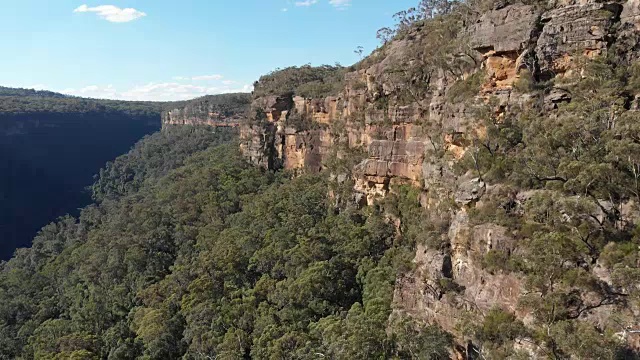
171,0,640,354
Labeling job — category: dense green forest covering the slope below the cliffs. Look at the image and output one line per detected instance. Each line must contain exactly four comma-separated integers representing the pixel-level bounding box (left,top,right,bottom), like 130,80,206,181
0,126,450,359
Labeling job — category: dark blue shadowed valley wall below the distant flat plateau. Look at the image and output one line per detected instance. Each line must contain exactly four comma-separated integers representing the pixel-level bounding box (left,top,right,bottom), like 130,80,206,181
0,113,160,260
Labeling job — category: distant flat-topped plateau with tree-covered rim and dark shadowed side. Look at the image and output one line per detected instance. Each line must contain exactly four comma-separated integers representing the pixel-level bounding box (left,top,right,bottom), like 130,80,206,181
0,88,246,259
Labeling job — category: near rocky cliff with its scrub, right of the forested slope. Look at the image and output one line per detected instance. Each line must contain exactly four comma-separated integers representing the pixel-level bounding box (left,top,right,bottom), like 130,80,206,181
181,1,640,358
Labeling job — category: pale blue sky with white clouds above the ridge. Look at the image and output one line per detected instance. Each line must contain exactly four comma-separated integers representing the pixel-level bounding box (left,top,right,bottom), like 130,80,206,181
0,0,417,100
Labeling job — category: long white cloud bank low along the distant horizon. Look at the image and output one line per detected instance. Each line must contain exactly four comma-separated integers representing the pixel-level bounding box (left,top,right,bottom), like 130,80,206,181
61,82,253,101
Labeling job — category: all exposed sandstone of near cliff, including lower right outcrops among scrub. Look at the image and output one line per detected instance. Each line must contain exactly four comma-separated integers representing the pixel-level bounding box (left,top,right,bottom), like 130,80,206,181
165,0,640,358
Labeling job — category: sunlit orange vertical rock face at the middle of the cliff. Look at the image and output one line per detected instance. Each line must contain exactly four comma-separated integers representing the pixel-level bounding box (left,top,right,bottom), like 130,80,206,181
241,87,436,202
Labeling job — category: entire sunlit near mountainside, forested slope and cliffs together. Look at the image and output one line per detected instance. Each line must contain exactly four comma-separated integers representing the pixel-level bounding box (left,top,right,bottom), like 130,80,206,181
0,0,640,360
